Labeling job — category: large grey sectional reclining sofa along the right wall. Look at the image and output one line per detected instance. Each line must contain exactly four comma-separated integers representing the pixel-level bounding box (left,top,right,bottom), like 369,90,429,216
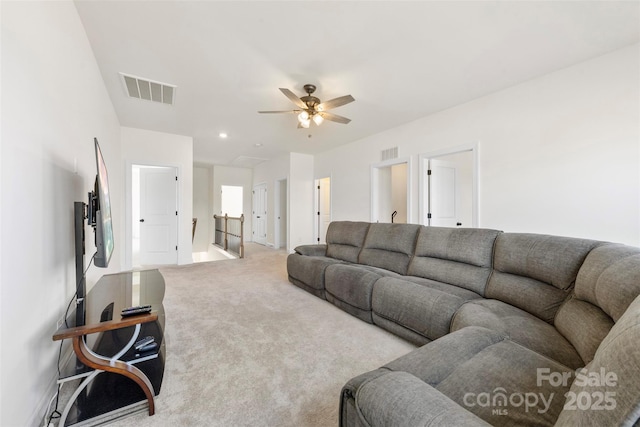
287,221,640,427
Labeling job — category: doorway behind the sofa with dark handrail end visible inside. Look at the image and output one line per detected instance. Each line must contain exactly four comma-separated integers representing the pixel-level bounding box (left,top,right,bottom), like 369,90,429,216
371,159,412,223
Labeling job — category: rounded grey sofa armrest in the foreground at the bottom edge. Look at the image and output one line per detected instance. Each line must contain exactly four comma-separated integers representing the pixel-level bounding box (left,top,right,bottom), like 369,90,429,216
355,372,489,427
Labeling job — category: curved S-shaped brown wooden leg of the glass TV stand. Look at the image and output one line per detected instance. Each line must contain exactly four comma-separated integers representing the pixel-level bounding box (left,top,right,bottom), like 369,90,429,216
73,335,155,415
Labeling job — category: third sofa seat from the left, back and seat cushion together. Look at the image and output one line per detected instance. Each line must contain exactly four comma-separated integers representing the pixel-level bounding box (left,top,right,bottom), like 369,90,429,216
372,226,501,345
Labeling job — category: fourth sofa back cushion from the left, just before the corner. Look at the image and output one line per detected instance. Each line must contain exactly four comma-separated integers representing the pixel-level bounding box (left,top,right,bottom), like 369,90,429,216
485,233,602,323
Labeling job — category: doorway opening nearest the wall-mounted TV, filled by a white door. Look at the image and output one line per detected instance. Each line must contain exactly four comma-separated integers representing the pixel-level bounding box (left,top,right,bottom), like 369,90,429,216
131,165,178,267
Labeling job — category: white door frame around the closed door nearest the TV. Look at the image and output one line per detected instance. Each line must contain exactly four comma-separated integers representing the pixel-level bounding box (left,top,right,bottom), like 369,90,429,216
124,160,180,270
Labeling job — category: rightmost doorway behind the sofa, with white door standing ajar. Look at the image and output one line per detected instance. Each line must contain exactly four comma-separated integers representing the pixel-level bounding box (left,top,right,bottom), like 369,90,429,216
419,144,479,227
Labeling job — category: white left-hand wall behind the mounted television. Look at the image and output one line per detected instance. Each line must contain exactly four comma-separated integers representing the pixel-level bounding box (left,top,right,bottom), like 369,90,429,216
0,1,124,426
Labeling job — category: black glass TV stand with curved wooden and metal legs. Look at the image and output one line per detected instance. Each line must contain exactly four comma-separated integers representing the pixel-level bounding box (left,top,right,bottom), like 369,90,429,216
53,270,165,426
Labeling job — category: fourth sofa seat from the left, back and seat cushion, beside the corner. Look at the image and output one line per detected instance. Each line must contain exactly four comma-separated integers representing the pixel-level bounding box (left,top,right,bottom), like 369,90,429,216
451,233,602,369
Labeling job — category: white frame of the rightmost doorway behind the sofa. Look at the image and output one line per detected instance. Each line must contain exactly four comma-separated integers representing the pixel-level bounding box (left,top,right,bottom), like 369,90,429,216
418,141,480,228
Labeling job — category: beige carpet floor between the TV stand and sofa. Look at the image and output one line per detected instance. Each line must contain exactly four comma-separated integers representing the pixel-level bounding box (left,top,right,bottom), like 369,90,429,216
106,245,415,427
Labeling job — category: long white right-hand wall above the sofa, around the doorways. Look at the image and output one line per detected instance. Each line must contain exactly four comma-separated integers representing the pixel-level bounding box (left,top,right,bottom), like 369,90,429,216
315,45,640,245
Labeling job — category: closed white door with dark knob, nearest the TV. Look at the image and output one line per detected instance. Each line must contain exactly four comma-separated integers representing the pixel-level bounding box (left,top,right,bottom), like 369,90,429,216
139,167,178,265
